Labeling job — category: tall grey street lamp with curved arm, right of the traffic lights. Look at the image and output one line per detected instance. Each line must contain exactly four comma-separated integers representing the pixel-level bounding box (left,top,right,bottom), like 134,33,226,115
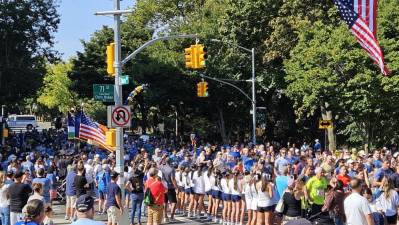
211,39,256,145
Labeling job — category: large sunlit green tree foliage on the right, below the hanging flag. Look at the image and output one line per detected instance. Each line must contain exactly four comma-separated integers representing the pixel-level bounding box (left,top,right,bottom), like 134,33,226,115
284,1,399,146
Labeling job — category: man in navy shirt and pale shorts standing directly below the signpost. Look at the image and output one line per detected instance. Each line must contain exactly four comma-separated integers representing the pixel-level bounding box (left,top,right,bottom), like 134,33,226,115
106,171,123,225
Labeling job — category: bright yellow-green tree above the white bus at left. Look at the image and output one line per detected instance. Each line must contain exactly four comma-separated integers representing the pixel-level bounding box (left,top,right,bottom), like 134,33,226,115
37,63,76,112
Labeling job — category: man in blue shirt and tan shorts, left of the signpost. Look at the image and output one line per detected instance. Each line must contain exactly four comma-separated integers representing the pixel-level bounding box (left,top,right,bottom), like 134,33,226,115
65,166,76,220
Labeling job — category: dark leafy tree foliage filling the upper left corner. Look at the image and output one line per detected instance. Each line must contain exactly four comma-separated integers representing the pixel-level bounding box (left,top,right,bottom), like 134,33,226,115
0,0,59,104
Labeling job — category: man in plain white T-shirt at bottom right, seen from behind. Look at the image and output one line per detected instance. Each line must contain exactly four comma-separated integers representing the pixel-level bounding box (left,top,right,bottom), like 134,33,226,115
344,178,374,225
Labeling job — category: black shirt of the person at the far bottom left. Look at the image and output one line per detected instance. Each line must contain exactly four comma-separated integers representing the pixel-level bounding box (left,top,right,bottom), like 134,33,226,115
8,183,32,213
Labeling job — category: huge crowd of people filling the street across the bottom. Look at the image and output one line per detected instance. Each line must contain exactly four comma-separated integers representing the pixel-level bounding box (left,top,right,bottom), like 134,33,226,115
0,128,399,225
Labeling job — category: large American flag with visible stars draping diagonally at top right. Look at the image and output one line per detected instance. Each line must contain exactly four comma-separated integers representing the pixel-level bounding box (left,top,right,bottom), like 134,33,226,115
334,0,389,75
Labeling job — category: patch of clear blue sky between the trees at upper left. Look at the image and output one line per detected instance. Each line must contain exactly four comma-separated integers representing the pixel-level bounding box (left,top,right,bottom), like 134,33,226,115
54,0,134,59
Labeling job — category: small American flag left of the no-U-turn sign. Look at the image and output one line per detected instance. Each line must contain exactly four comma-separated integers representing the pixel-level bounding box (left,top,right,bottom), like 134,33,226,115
79,113,105,145
